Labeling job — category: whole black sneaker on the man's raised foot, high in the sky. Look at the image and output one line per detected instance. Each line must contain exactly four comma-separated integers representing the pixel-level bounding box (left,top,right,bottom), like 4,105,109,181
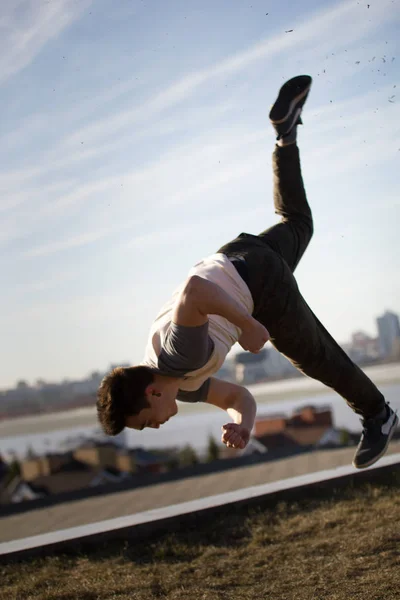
269,75,312,140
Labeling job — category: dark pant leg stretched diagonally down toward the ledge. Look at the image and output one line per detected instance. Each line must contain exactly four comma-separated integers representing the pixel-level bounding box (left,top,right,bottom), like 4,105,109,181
254,265,385,418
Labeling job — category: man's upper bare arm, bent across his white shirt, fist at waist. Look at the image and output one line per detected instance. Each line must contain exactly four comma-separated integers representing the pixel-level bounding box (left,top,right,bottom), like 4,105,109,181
172,275,269,352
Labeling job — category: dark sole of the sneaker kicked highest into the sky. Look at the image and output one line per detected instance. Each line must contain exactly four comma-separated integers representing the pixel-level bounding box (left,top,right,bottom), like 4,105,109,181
269,75,312,125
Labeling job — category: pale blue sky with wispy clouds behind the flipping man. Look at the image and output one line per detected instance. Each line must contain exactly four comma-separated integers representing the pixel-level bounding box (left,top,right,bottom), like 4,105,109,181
0,0,400,389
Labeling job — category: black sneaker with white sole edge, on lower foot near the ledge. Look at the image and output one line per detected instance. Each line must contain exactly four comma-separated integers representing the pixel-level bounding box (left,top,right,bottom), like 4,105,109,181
353,404,399,469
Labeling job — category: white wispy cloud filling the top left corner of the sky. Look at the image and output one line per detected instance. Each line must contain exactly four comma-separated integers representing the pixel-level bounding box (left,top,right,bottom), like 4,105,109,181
0,0,92,84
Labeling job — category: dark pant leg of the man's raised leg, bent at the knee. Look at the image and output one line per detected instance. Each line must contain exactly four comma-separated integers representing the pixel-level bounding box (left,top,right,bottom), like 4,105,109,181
259,144,313,272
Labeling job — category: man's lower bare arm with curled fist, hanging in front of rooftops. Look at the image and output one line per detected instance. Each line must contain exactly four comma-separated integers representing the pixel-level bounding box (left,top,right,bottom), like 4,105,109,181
207,377,257,448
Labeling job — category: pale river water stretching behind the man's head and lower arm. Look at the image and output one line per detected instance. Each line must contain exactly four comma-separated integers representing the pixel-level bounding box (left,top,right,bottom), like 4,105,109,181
0,365,400,458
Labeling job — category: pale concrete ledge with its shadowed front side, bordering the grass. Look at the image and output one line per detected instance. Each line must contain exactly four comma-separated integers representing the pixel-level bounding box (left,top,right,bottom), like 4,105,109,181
0,453,400,562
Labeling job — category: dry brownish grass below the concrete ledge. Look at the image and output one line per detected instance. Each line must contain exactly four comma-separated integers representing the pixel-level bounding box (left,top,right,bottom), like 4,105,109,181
0,474,400,600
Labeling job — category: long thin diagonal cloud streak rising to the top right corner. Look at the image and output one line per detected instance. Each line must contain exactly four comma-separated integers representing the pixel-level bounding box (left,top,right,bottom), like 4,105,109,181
0,0,394,195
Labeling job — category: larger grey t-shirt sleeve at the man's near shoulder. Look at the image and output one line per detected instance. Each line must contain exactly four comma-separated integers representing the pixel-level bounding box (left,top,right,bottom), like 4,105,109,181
157,322,214,377
